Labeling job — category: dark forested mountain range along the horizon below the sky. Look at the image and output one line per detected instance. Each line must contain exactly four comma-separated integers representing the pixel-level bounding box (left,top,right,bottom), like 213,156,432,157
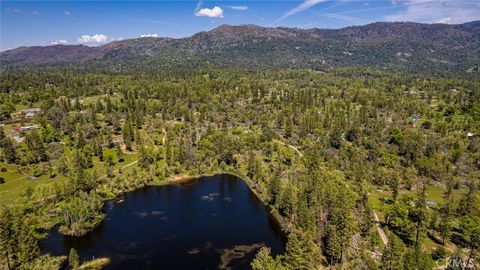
0,21,480,73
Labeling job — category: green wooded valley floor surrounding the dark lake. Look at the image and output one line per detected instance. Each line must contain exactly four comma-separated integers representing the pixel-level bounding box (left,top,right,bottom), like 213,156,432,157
0,68,480,269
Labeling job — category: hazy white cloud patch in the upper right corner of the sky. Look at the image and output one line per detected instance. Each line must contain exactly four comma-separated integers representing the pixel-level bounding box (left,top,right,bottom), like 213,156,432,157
385,0,480,23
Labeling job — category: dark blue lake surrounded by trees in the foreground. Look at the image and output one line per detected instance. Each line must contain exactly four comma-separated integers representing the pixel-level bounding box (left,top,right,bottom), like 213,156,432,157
42,175,285,270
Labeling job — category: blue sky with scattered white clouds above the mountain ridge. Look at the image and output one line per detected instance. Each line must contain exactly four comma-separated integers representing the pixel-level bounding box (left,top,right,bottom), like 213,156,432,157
0,0,480,51
